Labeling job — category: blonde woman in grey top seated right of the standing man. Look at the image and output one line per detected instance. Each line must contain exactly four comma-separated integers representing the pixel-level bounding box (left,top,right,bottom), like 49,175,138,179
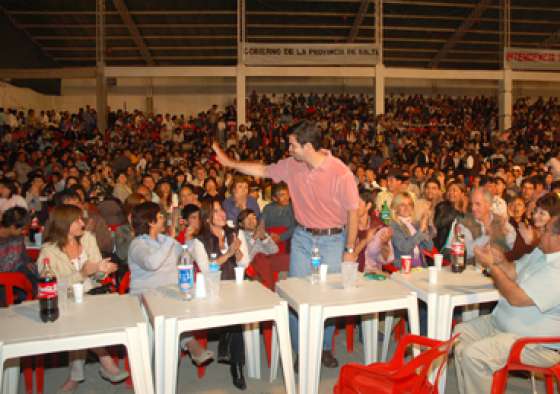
389,192,433,268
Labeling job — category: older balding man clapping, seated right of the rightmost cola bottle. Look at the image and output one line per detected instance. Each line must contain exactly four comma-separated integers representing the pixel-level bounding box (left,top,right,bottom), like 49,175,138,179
460,188,516,261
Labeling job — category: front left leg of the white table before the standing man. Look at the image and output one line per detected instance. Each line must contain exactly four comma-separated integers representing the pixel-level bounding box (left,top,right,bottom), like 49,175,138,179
307,305,325,394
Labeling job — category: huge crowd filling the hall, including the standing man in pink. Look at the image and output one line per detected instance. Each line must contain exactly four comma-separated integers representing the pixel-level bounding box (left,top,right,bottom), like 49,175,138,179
0,92,560,392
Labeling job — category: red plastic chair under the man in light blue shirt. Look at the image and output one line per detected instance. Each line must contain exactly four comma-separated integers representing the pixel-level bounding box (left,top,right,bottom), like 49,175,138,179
491,337,560,394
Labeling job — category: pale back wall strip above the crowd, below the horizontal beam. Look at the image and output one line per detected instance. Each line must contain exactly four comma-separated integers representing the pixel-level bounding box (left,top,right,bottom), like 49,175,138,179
0,77,560,115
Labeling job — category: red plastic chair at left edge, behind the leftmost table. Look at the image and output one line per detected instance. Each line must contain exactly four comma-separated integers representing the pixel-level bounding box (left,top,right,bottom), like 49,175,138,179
0,272,45,394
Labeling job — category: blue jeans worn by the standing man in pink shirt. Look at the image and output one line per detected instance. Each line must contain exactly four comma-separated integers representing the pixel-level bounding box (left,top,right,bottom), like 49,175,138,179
288,226,346,352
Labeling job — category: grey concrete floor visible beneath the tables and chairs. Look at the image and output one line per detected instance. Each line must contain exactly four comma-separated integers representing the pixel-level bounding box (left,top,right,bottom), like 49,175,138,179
19,332,545,394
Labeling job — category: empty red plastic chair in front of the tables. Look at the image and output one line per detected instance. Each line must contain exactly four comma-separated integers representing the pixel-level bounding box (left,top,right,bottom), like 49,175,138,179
334,335,458,394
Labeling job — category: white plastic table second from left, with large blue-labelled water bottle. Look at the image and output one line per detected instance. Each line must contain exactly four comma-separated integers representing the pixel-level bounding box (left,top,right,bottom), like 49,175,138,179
142,281,295,394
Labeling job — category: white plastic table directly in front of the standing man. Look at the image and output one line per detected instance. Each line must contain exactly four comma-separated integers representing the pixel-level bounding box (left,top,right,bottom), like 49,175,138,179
272,274,419,394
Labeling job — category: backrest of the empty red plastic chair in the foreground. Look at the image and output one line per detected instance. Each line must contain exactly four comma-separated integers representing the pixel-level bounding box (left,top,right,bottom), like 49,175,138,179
394,334,459,393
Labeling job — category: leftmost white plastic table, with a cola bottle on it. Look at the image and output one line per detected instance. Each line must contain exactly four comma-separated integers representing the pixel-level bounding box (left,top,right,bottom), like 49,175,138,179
0,294,154,394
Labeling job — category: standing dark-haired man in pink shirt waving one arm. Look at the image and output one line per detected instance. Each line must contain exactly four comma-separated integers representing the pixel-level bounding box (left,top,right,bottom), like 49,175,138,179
213,121,359,368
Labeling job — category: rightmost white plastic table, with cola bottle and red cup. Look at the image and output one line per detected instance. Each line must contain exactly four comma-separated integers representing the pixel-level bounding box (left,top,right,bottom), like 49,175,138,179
386,266,500,393
